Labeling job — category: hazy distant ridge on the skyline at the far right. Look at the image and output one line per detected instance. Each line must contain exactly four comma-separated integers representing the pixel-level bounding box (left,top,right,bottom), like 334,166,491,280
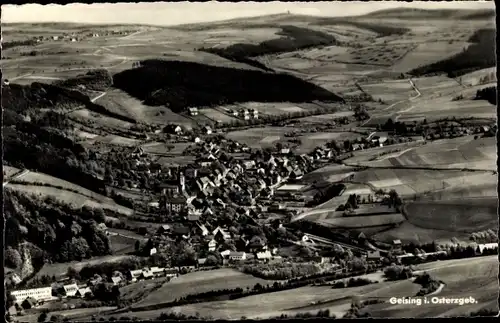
359,7,496,20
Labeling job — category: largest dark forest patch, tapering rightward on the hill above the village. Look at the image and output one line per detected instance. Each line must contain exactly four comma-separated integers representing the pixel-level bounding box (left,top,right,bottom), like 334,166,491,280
113,60,343,112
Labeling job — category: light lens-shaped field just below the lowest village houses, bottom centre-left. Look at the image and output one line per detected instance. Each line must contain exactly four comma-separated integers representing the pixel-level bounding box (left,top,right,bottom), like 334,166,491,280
133,269,273,308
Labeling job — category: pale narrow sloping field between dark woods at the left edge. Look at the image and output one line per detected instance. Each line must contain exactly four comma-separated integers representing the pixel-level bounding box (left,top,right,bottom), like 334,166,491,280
7,172,134,215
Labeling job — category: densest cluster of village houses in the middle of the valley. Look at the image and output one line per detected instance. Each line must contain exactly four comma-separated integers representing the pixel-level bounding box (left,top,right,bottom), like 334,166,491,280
161,142,313,219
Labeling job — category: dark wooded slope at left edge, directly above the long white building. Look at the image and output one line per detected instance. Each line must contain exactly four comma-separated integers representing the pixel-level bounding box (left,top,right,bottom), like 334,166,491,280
4,189,111,274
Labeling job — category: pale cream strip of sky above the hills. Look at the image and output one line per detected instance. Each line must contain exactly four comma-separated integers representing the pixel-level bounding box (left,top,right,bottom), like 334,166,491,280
2,1,495,26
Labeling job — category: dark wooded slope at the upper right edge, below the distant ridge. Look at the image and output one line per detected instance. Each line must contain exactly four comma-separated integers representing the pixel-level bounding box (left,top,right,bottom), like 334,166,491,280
409,29,496,77
